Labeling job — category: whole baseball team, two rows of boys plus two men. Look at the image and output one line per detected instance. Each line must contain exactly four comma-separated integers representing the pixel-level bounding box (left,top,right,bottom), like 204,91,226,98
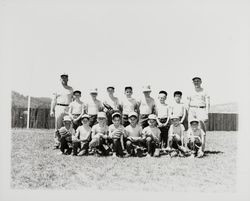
51,74,209,157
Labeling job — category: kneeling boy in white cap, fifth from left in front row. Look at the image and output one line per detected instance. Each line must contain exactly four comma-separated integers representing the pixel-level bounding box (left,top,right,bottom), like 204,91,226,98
125,112,143,156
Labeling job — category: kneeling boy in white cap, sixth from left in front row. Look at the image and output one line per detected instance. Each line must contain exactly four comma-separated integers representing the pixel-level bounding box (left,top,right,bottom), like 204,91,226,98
142,114,161,157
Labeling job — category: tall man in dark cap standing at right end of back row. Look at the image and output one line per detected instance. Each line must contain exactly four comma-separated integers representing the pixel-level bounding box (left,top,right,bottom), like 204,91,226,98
188,77,210,151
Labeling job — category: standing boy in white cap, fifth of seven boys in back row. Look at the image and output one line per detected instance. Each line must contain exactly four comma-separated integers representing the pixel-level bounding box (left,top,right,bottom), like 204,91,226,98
138,85,156,128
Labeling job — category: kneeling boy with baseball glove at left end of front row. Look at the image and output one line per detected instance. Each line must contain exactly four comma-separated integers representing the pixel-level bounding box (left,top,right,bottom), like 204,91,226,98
59,115,75,155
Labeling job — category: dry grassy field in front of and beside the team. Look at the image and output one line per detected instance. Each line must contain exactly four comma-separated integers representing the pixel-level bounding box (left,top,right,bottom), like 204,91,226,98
11,129,237,192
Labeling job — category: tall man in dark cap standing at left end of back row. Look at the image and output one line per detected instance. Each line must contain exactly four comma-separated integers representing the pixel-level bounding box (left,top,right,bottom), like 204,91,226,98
50,74,73,149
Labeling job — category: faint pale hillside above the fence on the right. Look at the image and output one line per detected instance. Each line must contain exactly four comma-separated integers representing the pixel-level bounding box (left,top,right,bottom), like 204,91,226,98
210,103,239,113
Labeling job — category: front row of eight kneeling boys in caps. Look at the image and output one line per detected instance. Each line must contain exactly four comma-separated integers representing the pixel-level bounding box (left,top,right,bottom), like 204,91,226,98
58,112,205,157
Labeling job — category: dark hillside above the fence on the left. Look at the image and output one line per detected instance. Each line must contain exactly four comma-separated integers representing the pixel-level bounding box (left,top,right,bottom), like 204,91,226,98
11,91,51,108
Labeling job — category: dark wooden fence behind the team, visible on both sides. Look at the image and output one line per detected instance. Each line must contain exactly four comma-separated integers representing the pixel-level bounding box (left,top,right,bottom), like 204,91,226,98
11,107,238,131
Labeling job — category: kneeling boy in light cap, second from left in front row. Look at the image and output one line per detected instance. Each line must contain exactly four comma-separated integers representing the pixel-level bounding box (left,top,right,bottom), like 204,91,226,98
72,114,91,156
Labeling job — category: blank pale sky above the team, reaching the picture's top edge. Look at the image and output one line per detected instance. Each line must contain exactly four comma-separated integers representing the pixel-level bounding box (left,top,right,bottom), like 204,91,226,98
1,0,249,104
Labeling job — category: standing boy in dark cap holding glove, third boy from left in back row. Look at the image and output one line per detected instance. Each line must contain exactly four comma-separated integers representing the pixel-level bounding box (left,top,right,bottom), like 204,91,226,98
103,86,121,126
